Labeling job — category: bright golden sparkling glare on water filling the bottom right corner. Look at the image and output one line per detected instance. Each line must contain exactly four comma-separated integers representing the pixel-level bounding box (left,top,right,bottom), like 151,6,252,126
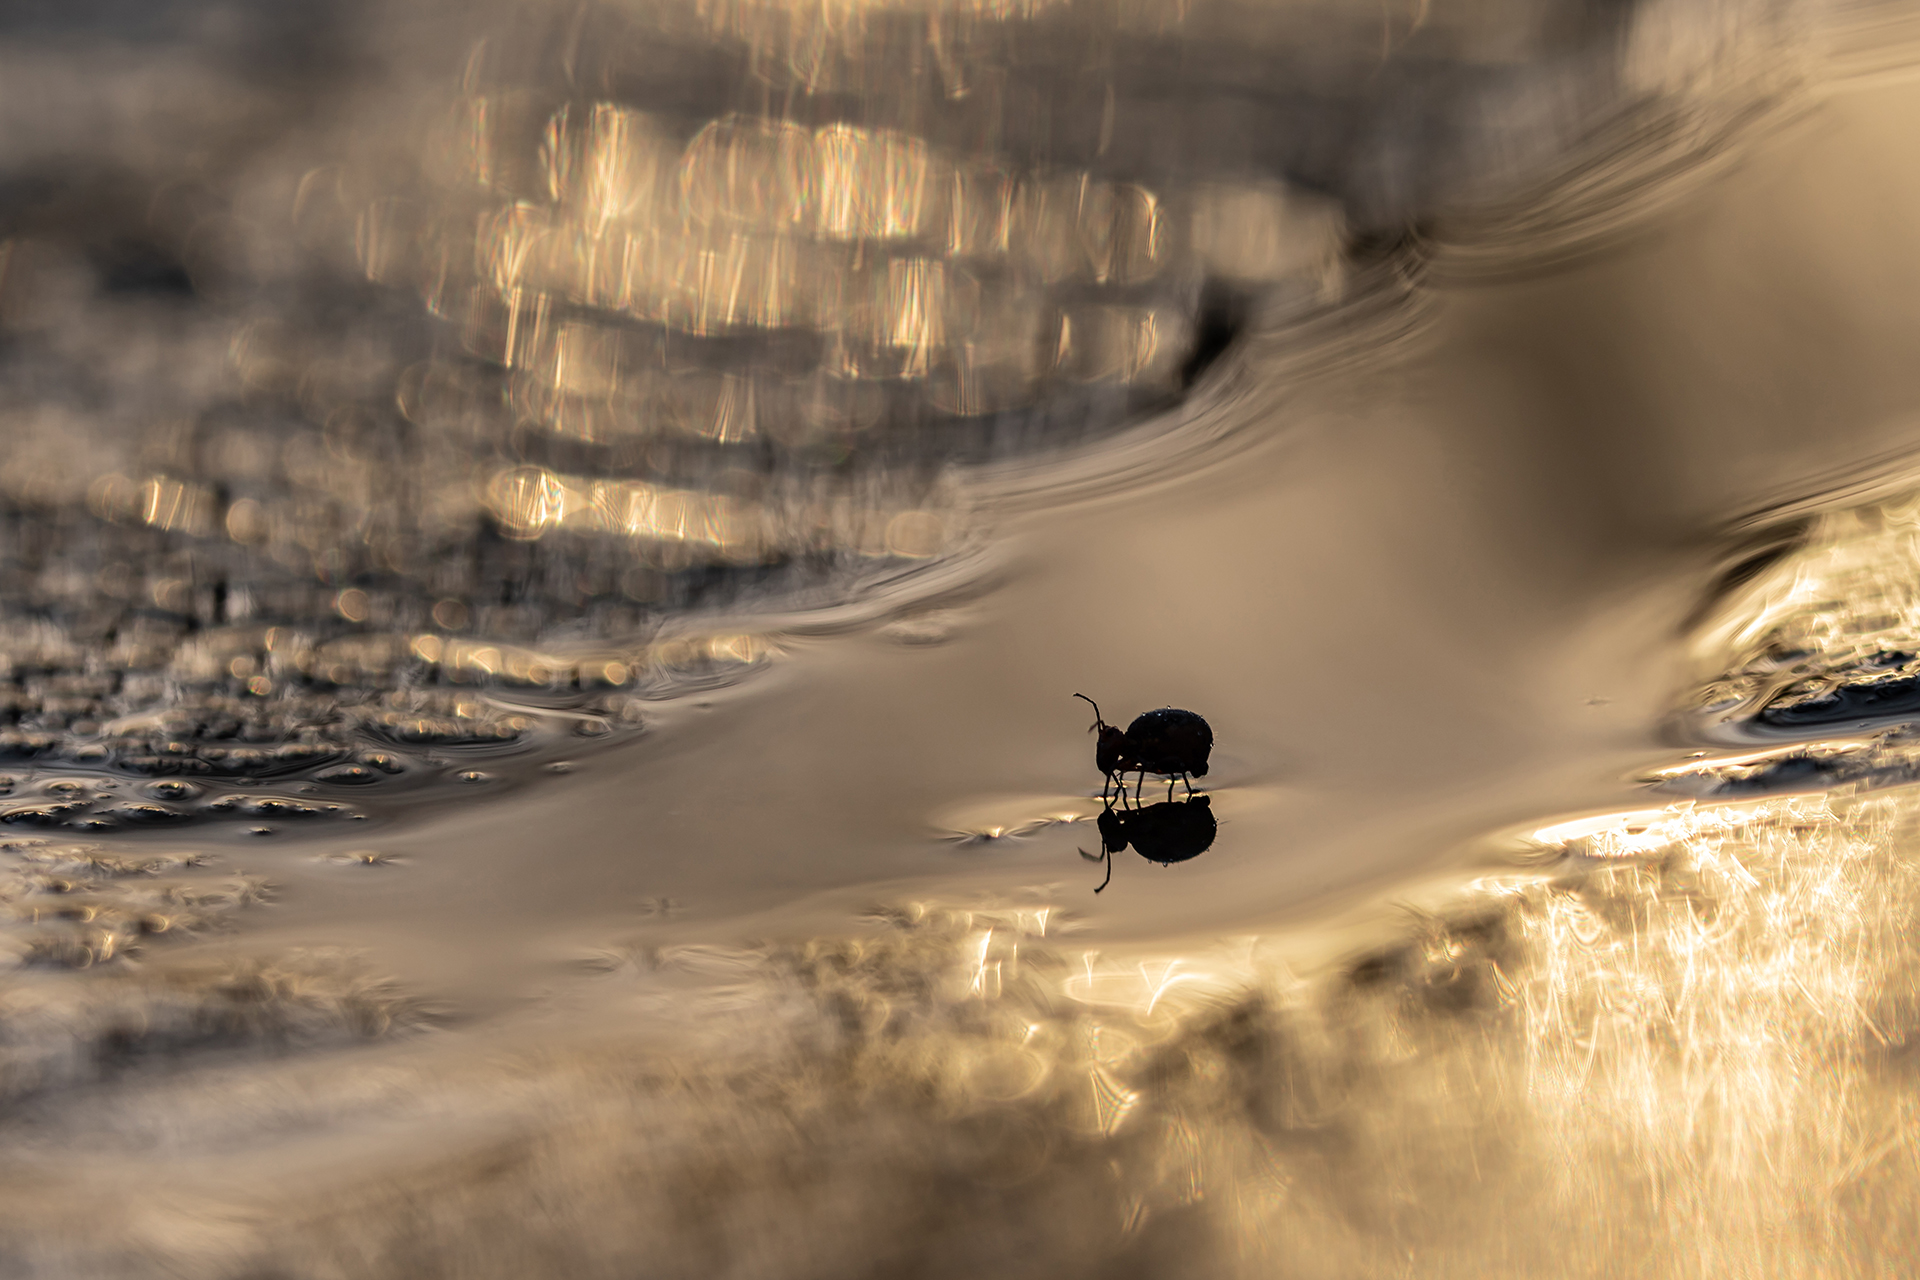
933,775,1920,1276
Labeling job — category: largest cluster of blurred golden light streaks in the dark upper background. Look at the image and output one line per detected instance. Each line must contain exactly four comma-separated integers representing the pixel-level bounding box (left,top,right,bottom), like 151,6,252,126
410,83,1342,401
